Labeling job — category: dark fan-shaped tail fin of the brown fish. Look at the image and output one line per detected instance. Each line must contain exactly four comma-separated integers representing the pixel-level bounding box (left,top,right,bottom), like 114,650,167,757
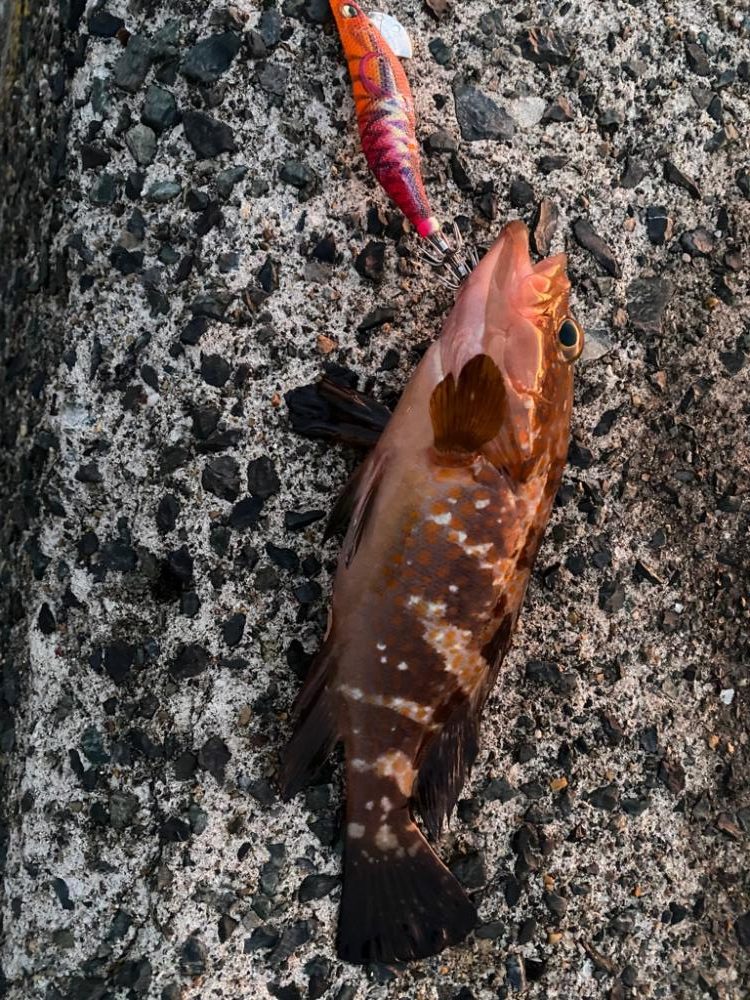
337,806,477,965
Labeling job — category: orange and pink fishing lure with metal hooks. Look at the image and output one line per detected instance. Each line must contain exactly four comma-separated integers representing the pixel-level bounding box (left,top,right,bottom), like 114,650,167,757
331,0,469,280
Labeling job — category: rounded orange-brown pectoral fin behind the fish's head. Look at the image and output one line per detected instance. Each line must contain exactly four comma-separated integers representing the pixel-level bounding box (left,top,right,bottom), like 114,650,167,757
430,354,508,453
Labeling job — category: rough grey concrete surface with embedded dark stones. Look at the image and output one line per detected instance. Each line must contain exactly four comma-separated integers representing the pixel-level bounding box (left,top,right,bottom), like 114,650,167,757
0,0,750,1000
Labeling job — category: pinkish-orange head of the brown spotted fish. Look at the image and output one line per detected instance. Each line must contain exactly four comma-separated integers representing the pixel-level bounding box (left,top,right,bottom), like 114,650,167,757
441,221,583,473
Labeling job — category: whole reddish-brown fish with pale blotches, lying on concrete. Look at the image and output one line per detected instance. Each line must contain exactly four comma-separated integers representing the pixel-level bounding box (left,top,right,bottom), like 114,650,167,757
281,221,583,963
